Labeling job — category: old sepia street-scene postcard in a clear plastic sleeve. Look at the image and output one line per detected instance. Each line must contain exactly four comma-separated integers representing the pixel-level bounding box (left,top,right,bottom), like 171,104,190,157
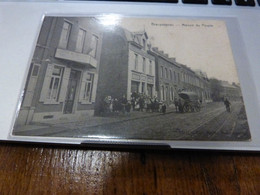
12,14,251,141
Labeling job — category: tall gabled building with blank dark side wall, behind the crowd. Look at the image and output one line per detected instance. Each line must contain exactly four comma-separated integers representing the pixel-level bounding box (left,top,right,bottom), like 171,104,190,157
95,27,155,114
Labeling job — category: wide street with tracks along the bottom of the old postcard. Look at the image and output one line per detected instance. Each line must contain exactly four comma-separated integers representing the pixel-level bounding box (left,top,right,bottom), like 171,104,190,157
15,102,250,141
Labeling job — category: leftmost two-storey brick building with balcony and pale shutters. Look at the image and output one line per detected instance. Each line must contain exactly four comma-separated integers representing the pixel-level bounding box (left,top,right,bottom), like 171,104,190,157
16,17,102,125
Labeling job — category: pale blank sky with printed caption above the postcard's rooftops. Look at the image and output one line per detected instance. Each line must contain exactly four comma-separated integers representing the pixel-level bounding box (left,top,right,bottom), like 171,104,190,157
99,18,238,83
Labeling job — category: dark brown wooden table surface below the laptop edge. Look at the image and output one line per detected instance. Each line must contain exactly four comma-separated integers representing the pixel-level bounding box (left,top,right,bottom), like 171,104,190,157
0,143,260,195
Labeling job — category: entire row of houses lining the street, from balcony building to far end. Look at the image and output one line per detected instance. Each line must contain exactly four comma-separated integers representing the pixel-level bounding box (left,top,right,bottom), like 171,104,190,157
16,17,236,125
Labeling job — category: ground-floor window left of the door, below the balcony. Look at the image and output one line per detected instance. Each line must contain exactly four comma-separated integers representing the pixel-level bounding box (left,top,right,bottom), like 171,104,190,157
47,66,64,102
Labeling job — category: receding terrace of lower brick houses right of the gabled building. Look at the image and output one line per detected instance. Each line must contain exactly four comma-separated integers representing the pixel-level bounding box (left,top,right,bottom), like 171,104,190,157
150,48,211,105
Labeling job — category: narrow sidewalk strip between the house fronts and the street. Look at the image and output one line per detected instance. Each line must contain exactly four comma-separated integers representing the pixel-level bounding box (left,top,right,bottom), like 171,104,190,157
14,107,175,136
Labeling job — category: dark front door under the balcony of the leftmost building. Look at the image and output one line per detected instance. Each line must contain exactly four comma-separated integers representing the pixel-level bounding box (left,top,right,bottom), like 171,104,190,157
63,69,80,114
